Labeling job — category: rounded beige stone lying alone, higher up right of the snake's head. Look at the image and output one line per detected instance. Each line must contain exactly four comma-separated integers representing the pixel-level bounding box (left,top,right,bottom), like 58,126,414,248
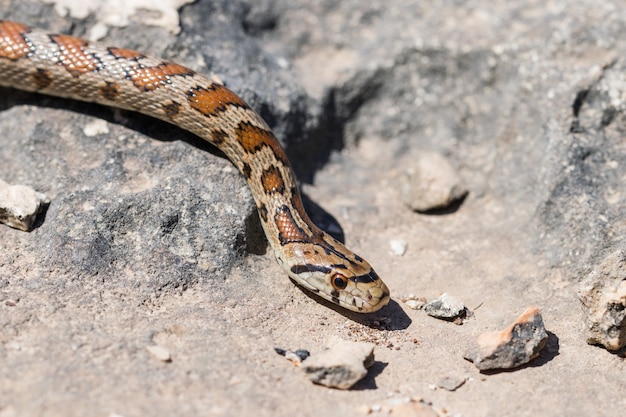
401,152,467,212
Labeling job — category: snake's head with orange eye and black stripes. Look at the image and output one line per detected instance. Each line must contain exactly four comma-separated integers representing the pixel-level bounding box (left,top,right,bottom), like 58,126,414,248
278,233,389,313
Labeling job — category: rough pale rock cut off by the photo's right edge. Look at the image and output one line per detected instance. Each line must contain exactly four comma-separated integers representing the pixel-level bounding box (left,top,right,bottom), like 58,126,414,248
578,250,626,350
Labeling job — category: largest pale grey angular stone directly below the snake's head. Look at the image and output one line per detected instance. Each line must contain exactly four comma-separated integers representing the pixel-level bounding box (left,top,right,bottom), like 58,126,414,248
302,340,374,389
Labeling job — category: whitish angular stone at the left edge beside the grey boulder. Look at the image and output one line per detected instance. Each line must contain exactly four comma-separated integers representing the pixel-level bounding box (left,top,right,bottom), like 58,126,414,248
0,180,50,232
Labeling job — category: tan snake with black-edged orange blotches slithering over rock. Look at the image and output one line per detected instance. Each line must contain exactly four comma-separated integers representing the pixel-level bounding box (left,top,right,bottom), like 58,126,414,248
0,20,390,313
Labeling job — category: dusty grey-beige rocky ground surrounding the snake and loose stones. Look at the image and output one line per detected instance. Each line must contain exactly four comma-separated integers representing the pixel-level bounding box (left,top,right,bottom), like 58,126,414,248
0,0,626,417
